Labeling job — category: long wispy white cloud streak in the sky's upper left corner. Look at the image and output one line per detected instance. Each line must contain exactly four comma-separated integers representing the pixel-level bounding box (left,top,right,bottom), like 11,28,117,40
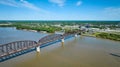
0,0,41,11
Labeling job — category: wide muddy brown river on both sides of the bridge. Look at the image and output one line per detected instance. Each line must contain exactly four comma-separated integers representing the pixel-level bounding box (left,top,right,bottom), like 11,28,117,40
0,28,120,67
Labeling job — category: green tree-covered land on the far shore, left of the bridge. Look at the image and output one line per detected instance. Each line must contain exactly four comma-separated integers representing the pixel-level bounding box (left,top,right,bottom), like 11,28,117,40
1,23,61,33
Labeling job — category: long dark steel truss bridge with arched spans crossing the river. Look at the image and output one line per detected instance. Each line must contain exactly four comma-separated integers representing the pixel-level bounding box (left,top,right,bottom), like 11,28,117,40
0,34,74,62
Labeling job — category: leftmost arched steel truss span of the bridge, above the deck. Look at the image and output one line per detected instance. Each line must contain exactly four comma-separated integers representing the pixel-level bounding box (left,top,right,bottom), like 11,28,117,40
0,40,37,57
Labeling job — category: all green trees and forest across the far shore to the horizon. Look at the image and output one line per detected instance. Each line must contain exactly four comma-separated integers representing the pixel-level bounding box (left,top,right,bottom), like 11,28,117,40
0,21,120,41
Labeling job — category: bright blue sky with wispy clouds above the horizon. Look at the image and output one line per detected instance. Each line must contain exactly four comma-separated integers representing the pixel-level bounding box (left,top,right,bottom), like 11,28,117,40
0,0,120,20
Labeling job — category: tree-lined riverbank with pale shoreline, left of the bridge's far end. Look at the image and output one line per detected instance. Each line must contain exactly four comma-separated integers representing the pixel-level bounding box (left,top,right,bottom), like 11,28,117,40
0,24,62,33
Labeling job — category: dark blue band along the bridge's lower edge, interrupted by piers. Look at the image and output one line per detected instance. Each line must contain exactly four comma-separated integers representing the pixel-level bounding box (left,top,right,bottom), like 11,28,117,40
0,36,73,62
